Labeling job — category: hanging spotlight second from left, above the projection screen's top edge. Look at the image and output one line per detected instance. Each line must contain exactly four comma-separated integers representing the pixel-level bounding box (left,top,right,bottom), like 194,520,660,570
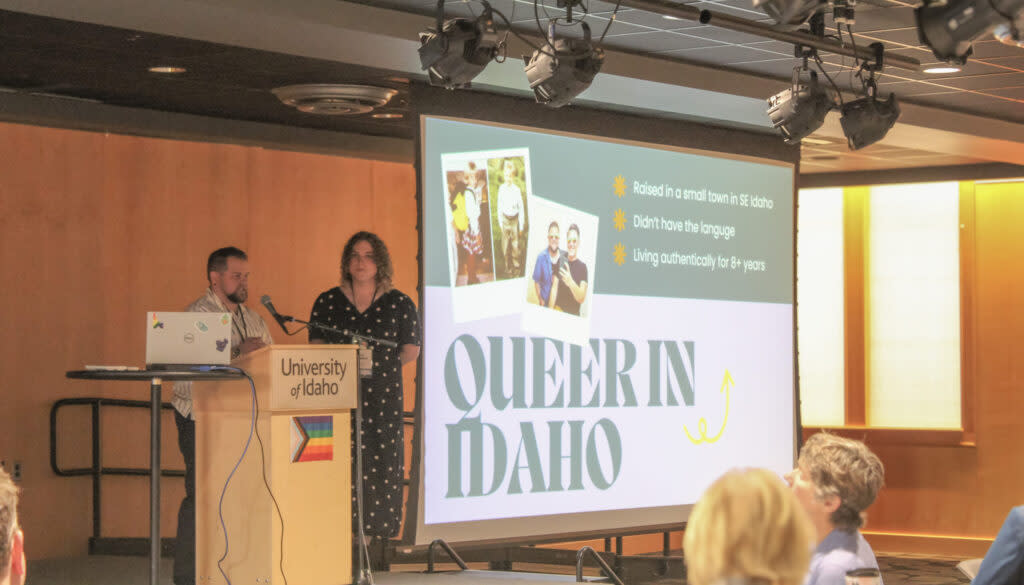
523,22,604,108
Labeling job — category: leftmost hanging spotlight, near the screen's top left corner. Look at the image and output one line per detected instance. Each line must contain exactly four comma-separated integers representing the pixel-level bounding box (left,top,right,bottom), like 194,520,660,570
420,0,498,89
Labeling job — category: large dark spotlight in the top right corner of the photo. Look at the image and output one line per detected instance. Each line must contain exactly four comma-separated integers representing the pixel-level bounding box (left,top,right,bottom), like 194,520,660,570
913,0,1024,65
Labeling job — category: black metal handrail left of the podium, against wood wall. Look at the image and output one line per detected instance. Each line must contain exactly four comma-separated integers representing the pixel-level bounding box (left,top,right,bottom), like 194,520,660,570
50,398,185,539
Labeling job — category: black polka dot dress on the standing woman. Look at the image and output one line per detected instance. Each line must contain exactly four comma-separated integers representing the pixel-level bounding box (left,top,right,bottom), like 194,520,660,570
309,287,420,538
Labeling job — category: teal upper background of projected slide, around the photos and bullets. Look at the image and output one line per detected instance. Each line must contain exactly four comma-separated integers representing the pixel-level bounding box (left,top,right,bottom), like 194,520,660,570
422,117,794,303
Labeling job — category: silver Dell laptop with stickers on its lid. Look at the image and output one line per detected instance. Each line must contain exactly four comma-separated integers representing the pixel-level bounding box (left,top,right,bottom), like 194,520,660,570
145,310,231,370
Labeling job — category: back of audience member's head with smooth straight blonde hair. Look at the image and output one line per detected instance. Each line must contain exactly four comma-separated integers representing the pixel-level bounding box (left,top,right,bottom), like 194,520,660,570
683,469,814,585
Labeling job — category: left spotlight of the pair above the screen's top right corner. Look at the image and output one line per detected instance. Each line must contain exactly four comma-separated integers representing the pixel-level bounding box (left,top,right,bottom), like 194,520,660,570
768,66,835,144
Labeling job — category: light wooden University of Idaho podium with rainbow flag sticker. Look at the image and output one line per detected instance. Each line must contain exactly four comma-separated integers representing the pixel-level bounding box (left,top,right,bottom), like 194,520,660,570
193,345,359,585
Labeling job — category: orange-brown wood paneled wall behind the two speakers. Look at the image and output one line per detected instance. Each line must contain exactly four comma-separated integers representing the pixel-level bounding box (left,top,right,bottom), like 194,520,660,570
0,124,419,558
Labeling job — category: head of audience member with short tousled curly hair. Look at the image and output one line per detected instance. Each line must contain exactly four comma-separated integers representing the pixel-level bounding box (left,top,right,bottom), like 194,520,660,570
785,432,885,539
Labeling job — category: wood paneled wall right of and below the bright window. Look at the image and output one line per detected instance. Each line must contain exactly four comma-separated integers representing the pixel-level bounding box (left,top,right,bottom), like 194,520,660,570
868,182,1024,556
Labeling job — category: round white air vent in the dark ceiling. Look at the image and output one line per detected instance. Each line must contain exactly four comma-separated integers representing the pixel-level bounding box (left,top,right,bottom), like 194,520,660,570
270,83,398,116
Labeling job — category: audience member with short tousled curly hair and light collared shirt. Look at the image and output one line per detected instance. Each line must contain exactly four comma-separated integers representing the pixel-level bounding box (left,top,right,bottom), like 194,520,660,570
785,432,885,585
